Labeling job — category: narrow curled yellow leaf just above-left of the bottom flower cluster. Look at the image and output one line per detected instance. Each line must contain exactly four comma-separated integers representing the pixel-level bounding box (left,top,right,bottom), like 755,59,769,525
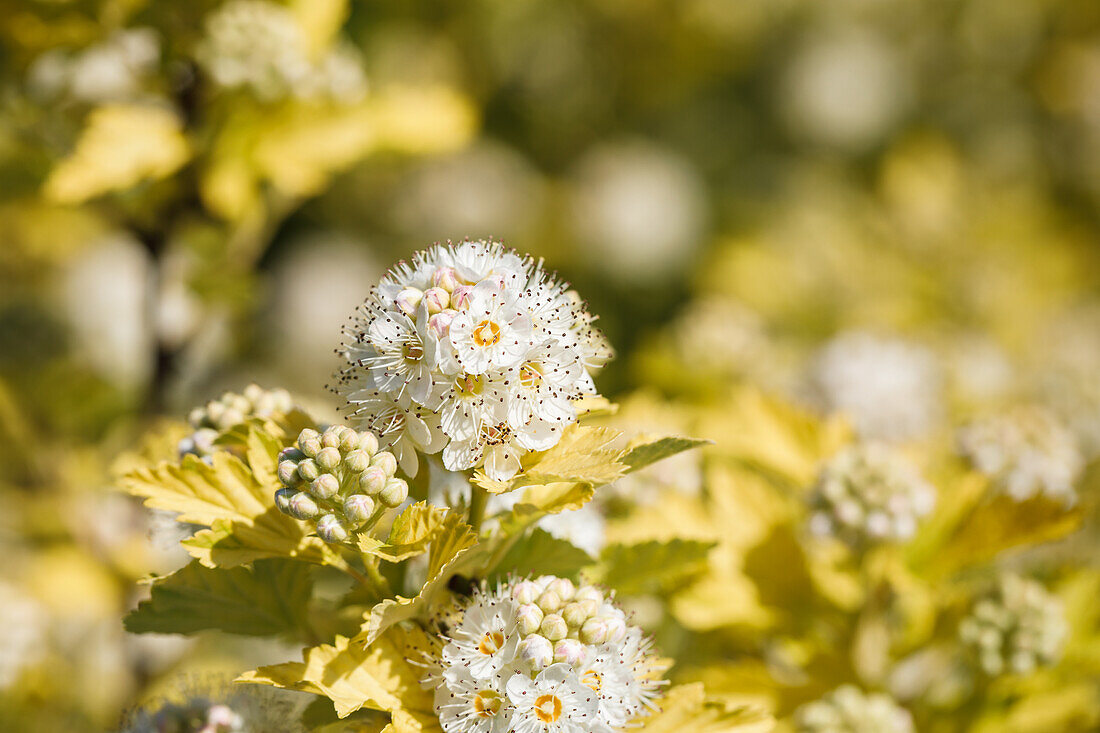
360,512,477,645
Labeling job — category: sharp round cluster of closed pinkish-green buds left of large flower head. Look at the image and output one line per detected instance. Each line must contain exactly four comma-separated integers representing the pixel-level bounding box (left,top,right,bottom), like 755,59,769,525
275,425,409,543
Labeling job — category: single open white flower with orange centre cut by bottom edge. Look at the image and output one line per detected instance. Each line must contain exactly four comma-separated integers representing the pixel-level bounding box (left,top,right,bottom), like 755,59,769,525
507,664,597,733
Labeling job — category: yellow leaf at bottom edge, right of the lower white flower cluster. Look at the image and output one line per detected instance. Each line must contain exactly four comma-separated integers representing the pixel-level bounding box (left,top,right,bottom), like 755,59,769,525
636,682,776,733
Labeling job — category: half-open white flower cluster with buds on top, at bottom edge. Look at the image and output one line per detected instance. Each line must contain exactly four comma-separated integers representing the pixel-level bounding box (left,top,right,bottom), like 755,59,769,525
425,576,663,733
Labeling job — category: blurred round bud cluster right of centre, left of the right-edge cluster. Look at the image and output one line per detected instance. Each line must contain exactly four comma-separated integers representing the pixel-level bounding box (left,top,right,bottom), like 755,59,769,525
810,444,936,547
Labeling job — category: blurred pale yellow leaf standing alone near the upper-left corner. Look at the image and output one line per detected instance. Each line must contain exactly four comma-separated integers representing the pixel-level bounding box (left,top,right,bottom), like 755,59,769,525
43,105,190,204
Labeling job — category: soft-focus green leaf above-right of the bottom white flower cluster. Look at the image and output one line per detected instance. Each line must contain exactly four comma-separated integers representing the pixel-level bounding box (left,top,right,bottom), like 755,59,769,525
596,539,715,595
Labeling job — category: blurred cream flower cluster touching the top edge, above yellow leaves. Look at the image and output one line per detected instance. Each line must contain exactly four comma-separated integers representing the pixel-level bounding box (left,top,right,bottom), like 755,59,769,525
197,0,366,102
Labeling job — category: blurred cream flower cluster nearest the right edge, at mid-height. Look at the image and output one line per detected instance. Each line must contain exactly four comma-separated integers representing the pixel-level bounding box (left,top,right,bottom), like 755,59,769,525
959,407,1085,504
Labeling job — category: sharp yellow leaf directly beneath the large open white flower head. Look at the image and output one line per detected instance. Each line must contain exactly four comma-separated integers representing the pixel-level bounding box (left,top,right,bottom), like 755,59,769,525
473,423,627,493
